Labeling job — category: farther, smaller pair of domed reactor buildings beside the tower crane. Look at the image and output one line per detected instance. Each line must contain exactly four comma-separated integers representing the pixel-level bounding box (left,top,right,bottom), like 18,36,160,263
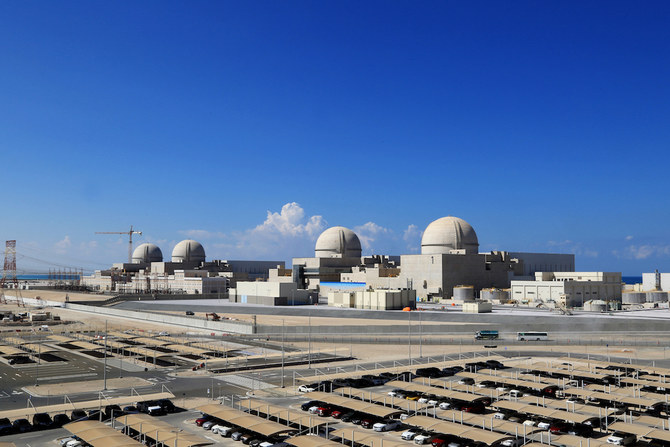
82,239,285,297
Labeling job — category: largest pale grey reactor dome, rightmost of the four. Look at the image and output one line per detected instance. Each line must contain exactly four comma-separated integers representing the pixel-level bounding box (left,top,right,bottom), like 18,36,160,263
421,216,479,255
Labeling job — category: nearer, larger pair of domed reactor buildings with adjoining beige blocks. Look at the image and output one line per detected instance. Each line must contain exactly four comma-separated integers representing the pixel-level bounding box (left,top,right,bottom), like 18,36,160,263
280,216,575,300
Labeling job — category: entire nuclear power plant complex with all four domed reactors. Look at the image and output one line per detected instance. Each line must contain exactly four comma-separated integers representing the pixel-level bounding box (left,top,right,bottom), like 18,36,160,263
83,216,644,309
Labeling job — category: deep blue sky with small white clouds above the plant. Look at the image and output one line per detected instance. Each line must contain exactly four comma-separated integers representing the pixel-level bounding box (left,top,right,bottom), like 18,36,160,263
0,1,670,274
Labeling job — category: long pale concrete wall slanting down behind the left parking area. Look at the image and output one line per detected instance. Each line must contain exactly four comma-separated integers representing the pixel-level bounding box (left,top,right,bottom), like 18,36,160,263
64,303,255,334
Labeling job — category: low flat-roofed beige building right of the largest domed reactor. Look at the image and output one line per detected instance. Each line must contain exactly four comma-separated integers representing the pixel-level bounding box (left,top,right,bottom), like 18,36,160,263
510,272,621,307
